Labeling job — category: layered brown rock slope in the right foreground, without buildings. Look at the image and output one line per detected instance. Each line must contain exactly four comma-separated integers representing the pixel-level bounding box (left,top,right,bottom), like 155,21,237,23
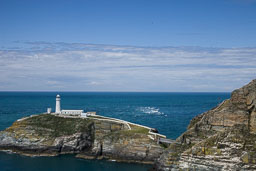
156,80,256,170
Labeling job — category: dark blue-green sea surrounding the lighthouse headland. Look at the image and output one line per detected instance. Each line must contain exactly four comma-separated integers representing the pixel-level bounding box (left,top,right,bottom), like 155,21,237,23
0,92,230,171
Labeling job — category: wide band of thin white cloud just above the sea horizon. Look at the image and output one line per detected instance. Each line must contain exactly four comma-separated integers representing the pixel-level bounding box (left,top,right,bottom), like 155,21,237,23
0,42,256,91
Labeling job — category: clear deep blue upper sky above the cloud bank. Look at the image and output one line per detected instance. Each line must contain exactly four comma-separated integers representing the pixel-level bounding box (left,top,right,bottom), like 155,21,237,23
0,0,256,47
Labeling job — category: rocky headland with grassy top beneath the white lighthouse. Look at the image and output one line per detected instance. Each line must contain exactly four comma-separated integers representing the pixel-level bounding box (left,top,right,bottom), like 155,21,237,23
0,114,163,163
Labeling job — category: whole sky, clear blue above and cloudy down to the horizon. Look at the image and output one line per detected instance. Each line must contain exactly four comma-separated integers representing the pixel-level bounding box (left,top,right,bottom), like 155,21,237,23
0,0,256,92
